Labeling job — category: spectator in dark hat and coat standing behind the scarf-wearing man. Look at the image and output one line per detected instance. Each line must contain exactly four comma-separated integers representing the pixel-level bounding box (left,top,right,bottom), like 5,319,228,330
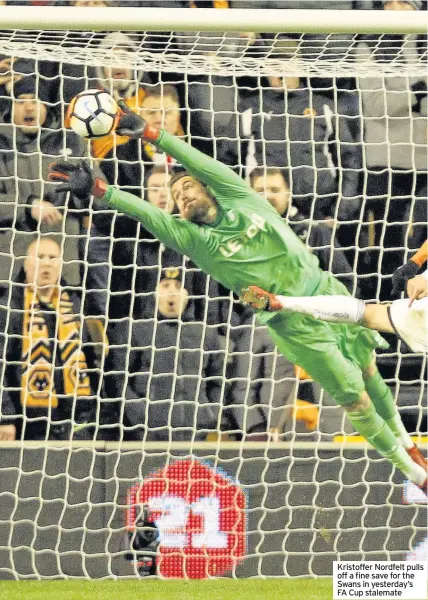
0,76,97,285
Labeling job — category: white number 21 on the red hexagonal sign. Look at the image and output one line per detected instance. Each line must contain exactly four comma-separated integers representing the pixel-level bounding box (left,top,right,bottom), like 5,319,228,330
149,496,228,548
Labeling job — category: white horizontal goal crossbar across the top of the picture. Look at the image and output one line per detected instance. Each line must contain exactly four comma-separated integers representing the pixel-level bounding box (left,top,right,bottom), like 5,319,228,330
2,6,428,33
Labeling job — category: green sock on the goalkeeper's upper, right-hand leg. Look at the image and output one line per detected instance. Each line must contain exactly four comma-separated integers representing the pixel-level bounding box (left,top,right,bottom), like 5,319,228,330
365,369,413,448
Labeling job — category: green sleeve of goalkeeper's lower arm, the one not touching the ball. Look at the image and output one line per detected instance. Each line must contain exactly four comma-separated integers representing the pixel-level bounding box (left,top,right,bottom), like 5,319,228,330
104,186,198,254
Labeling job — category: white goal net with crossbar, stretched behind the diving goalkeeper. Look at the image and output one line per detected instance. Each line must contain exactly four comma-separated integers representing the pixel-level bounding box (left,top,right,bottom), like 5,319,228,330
0,3,427,579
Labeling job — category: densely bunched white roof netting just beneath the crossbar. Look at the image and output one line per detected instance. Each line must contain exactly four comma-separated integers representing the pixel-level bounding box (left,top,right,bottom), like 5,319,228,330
0,31,427,77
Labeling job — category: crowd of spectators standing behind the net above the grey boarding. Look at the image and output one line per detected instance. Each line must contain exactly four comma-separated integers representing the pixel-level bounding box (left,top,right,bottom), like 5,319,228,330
0,0,428,442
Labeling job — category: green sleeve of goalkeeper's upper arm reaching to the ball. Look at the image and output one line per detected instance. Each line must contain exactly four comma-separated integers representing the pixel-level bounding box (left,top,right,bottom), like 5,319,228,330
156,129,255,204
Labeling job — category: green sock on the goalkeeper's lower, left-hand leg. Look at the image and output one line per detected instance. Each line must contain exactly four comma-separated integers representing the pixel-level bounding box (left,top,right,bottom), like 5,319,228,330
347,403,426,485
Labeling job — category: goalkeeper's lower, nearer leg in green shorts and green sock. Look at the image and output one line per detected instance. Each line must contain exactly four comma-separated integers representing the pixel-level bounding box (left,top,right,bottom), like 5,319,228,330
268,313,426,485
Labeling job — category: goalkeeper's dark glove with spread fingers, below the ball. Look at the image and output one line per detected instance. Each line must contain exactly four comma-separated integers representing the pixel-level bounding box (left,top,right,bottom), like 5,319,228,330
48,160,108,200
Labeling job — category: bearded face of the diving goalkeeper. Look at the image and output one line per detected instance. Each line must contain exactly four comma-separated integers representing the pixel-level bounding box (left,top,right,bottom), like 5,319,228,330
171,176,216,223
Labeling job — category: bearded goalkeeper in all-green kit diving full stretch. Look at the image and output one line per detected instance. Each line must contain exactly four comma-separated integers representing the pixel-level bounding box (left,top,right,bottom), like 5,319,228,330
50,104,426,486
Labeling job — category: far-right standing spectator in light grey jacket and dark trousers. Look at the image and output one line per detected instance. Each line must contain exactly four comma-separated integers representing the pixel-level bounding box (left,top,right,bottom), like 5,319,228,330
357,0,427,299
